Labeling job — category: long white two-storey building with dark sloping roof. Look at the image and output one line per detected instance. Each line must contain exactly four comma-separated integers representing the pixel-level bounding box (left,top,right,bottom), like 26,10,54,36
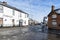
0,2,29,27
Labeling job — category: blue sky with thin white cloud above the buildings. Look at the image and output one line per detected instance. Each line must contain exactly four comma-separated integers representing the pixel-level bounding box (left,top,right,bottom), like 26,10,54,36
0,0,60,22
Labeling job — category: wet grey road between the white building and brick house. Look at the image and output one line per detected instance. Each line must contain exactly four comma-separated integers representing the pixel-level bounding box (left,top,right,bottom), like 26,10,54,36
0,25,58,40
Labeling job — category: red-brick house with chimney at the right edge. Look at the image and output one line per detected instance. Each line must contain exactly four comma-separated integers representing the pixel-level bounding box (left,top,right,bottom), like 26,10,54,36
48,6,60,30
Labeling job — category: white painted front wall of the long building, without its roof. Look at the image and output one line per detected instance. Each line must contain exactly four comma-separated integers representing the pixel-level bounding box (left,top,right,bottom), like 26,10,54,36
0,6,29,26
